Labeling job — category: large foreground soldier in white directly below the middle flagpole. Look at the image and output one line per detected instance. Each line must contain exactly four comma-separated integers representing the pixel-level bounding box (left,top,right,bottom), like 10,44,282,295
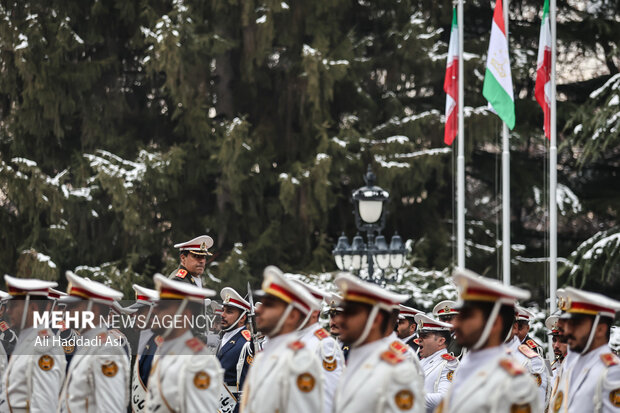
437,268,544,413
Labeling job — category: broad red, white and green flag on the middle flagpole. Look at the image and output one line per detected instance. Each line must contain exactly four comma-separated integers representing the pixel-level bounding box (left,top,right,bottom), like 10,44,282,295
482,0,515,129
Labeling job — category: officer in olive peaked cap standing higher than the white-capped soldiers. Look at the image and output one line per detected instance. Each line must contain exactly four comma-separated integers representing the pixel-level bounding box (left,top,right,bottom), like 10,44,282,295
169,235,213,288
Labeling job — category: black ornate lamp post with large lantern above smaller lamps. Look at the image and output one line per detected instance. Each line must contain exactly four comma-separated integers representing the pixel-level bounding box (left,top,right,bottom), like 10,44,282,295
332,165,406,282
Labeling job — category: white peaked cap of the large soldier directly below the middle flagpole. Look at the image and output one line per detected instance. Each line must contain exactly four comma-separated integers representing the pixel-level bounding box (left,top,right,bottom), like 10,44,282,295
452,268,530,306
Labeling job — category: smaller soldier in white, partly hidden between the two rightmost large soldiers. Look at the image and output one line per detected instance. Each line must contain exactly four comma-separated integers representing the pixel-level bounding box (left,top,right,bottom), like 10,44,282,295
506,305,550,402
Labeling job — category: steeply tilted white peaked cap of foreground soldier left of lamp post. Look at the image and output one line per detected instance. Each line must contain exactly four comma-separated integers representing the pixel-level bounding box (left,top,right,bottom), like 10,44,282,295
261,265,321,314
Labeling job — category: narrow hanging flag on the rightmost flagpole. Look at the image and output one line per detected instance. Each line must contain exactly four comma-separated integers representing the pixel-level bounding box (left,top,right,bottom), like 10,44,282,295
534,0,551,139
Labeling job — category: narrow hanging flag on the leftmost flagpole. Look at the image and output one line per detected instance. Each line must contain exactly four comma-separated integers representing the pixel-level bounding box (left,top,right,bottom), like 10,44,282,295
443,8,459,145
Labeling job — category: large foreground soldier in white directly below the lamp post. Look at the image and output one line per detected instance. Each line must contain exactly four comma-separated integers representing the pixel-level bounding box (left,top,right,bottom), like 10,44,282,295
333,274,425,413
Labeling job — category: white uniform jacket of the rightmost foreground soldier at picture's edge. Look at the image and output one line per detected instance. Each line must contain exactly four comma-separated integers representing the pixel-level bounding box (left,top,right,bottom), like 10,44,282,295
549,345,620,413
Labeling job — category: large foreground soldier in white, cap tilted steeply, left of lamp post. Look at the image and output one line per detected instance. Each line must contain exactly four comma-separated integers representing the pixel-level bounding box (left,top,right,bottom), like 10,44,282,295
241,266,323,413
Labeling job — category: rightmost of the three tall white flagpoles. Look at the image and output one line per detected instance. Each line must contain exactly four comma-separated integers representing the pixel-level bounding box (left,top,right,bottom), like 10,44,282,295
549,0,558,322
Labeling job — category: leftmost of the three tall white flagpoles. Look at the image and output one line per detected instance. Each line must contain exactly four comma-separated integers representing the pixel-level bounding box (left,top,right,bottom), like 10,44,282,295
456,0,465,268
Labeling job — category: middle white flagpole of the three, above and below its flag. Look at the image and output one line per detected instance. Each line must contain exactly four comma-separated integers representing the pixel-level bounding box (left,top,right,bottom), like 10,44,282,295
502,0,510,285
